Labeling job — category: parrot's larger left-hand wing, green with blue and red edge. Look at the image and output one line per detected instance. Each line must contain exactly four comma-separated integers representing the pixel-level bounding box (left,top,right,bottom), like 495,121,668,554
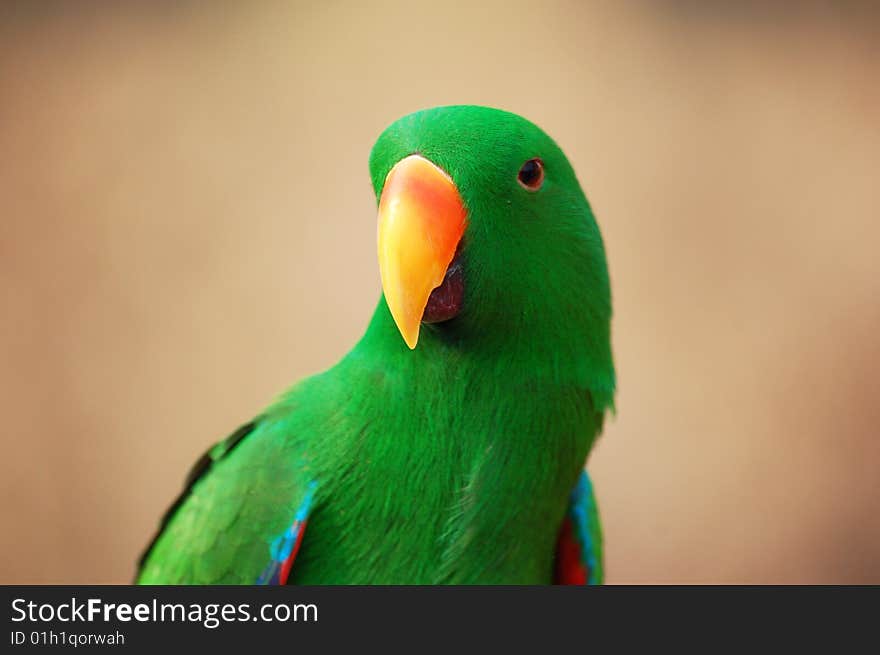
137,418,315,584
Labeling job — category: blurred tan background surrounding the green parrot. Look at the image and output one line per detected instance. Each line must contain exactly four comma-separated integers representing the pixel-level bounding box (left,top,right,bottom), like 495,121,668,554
0,0,880,583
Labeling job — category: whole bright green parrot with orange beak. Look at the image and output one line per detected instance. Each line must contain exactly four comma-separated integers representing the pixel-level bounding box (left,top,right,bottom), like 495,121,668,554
137,106,615,584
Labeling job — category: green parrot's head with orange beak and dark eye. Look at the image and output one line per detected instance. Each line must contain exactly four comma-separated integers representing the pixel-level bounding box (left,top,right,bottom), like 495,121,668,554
370,106,614,404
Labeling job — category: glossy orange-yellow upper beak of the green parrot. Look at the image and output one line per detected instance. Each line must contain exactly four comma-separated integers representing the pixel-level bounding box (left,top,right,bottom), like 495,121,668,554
379,155,467,349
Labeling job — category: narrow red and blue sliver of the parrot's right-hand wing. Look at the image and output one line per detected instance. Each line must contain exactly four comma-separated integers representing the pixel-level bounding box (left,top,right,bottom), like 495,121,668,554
556,471,604,585
